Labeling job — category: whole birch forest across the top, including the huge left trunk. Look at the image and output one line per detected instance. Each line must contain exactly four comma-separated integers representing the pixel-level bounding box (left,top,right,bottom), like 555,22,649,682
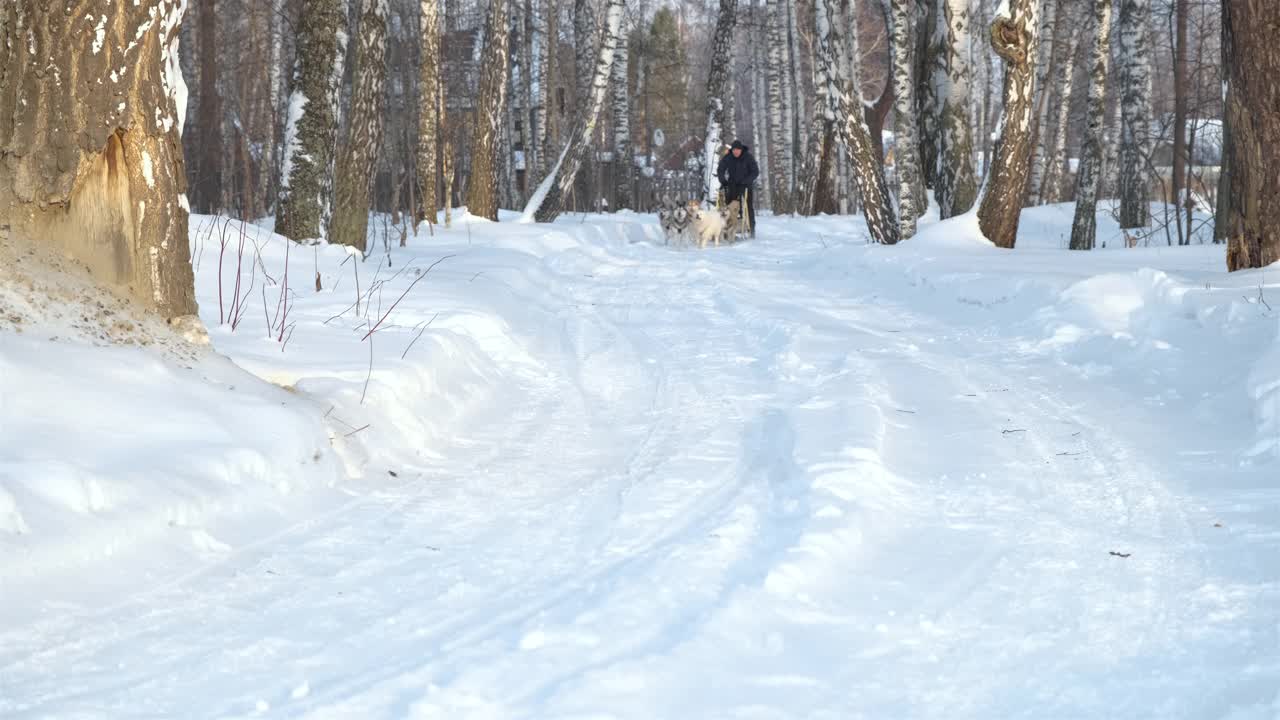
0,0,1280,315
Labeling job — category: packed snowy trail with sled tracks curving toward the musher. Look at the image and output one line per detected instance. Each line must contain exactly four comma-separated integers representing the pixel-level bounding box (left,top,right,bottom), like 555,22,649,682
0,210,1280,720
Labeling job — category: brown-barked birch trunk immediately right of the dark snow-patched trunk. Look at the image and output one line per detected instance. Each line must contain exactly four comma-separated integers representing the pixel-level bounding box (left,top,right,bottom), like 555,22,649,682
329,0,388,251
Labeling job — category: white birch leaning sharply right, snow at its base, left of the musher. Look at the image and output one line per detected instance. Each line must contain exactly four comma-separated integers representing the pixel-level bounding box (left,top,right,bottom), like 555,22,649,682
525,0,626,223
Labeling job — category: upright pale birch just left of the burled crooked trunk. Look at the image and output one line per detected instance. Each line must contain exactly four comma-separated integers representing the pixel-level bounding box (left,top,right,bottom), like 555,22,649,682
934,0,978,219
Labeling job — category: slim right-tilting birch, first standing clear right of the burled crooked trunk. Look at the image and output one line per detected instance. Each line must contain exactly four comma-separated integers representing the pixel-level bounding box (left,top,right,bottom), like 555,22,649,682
1070,0,1111,250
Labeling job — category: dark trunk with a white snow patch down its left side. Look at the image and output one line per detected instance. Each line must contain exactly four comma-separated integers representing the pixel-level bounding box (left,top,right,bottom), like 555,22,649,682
275,0,347,241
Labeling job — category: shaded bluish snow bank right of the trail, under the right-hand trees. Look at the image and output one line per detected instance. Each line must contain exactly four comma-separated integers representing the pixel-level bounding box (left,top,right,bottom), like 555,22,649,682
815,204,1280,459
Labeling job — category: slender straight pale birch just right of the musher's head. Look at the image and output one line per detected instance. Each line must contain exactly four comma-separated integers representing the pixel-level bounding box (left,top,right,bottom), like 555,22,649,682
765,0,796,215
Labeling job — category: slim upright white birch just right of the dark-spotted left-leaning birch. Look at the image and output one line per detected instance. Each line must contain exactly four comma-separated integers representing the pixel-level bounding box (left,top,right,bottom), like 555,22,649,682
890,0,921,240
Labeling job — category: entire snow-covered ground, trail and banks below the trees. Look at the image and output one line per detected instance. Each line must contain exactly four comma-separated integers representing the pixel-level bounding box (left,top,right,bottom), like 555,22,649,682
0,206,1280,720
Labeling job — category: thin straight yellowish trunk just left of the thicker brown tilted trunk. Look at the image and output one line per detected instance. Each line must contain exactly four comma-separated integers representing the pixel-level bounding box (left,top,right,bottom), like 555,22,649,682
415,0,440,224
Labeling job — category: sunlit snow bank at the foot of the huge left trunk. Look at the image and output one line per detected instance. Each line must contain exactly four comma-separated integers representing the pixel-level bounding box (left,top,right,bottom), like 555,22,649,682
0,230,342,598
